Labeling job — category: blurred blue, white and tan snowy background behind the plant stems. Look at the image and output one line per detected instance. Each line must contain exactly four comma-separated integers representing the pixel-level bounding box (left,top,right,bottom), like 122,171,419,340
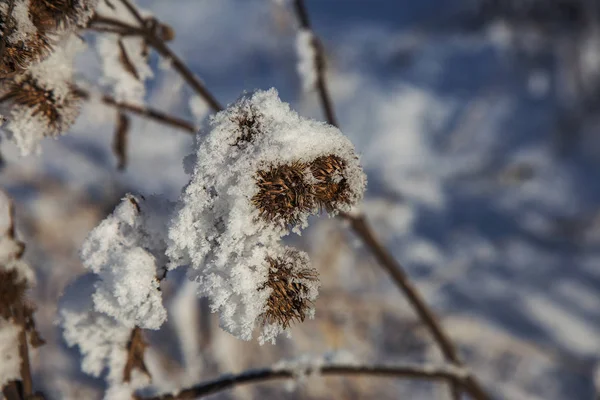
0,0,600,400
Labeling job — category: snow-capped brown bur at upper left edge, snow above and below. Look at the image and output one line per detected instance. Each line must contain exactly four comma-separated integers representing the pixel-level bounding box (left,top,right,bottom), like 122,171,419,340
0,34,84,155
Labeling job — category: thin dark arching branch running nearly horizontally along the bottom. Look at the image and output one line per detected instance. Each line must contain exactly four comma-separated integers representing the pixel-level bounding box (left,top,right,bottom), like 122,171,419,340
138,364,467,400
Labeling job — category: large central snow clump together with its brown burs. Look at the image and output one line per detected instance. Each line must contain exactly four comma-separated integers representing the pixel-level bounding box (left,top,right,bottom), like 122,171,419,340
167,89,366,341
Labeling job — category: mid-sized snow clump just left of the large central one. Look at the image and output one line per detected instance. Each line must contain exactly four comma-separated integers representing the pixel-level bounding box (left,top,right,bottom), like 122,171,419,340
81,195,171,329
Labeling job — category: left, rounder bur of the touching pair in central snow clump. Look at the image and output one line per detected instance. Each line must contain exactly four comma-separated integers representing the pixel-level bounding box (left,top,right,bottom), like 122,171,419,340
252,162,314,225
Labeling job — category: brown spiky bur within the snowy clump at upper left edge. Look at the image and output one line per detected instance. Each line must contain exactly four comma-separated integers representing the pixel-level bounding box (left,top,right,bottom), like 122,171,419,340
0,74,81,136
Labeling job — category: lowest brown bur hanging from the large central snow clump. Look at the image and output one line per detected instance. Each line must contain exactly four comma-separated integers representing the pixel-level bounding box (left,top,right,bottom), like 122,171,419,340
262,250,319,329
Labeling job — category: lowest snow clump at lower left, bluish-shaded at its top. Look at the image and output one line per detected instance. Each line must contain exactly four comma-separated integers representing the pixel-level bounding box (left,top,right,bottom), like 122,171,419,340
59,274,149,400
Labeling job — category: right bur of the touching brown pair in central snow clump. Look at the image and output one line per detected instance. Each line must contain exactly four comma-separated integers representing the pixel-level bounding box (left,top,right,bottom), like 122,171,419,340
310,155,350,212
